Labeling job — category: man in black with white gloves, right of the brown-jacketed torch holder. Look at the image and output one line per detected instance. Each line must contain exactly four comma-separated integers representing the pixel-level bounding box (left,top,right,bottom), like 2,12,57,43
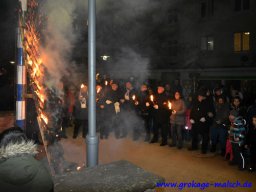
189,89,210,154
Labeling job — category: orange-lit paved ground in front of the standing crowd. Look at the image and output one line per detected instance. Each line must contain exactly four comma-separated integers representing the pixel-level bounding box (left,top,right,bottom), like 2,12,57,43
61,129,256,192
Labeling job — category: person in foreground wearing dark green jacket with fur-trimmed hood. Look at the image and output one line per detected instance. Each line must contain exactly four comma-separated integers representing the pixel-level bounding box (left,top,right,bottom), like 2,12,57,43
0,127,54,192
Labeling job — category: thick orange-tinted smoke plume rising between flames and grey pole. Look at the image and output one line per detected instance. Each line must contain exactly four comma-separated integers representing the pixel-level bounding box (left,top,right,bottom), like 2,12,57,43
41,0,78,91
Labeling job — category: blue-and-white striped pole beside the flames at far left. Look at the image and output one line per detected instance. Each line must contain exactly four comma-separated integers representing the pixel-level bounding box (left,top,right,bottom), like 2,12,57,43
16,24,26,129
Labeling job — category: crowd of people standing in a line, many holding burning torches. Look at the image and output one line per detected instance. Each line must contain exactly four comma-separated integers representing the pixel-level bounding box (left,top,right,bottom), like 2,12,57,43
59,79,256,171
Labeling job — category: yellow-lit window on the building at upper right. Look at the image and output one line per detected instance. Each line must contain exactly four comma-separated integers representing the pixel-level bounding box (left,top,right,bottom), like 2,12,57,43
234,32,250,52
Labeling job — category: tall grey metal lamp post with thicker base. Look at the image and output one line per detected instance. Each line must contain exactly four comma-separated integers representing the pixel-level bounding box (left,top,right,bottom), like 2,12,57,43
86,0,99,167
